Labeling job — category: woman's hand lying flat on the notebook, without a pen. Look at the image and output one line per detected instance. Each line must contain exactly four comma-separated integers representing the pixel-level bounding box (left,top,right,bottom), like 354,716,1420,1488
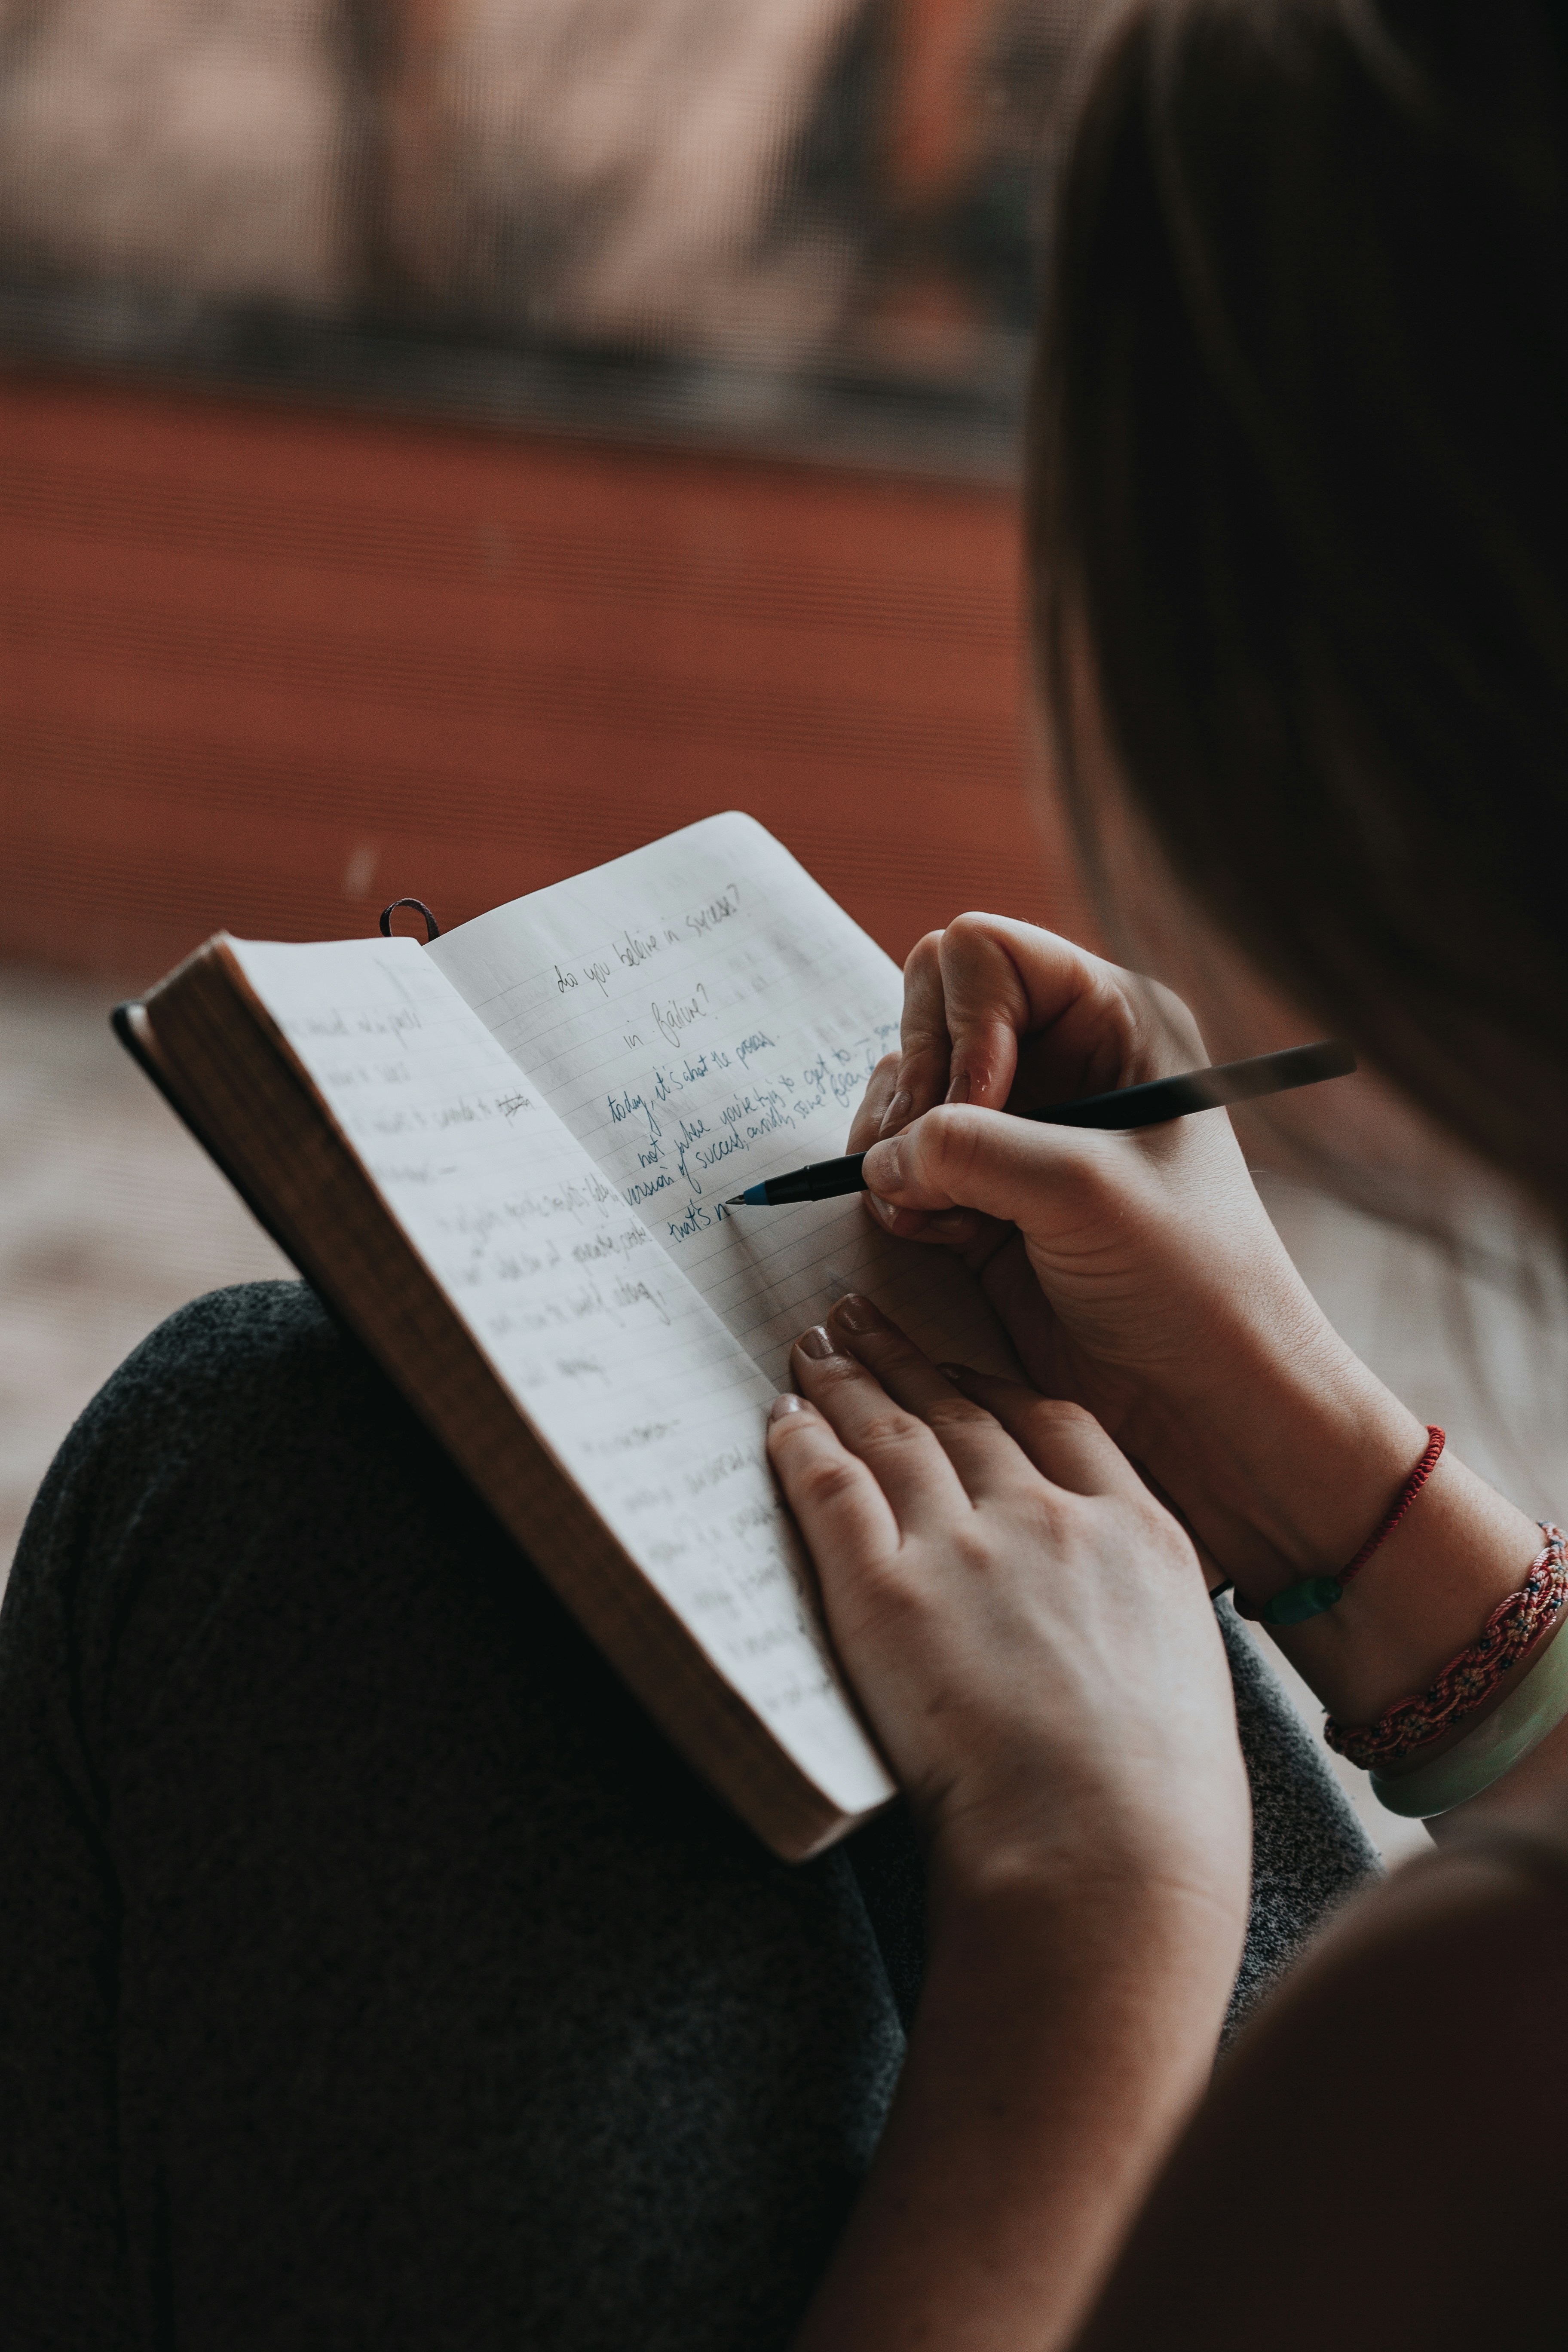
769,1298,1248,1910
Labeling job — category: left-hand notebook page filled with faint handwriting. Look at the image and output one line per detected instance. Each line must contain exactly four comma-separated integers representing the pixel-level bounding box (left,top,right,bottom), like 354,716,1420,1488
233,938,891,1813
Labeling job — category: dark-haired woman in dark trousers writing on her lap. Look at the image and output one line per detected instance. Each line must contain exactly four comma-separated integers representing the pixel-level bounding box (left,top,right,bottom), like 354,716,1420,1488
0,0,1568,2352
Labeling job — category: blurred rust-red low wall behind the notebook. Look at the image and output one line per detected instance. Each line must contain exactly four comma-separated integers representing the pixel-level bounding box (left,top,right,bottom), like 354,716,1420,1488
0,377,1081,981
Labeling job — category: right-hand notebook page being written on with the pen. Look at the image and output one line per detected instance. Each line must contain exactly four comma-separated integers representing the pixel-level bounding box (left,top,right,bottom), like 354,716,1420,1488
426,814,1018,1385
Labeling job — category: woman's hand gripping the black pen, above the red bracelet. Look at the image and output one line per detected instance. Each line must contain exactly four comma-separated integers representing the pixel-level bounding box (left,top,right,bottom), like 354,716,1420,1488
848,915,1424,1592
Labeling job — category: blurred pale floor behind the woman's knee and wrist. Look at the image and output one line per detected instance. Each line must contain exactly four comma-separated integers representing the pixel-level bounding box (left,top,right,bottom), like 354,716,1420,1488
0,950,1568,1858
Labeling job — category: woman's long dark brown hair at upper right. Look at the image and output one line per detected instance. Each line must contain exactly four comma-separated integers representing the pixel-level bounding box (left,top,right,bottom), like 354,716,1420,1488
1030,0,1568,1214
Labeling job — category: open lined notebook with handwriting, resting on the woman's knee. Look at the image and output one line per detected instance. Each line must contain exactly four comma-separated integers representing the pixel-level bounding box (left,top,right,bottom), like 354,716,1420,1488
117,814,1013,1856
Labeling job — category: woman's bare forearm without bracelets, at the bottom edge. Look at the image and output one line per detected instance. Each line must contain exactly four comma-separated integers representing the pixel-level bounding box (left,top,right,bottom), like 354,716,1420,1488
797,1874,1241,2352
